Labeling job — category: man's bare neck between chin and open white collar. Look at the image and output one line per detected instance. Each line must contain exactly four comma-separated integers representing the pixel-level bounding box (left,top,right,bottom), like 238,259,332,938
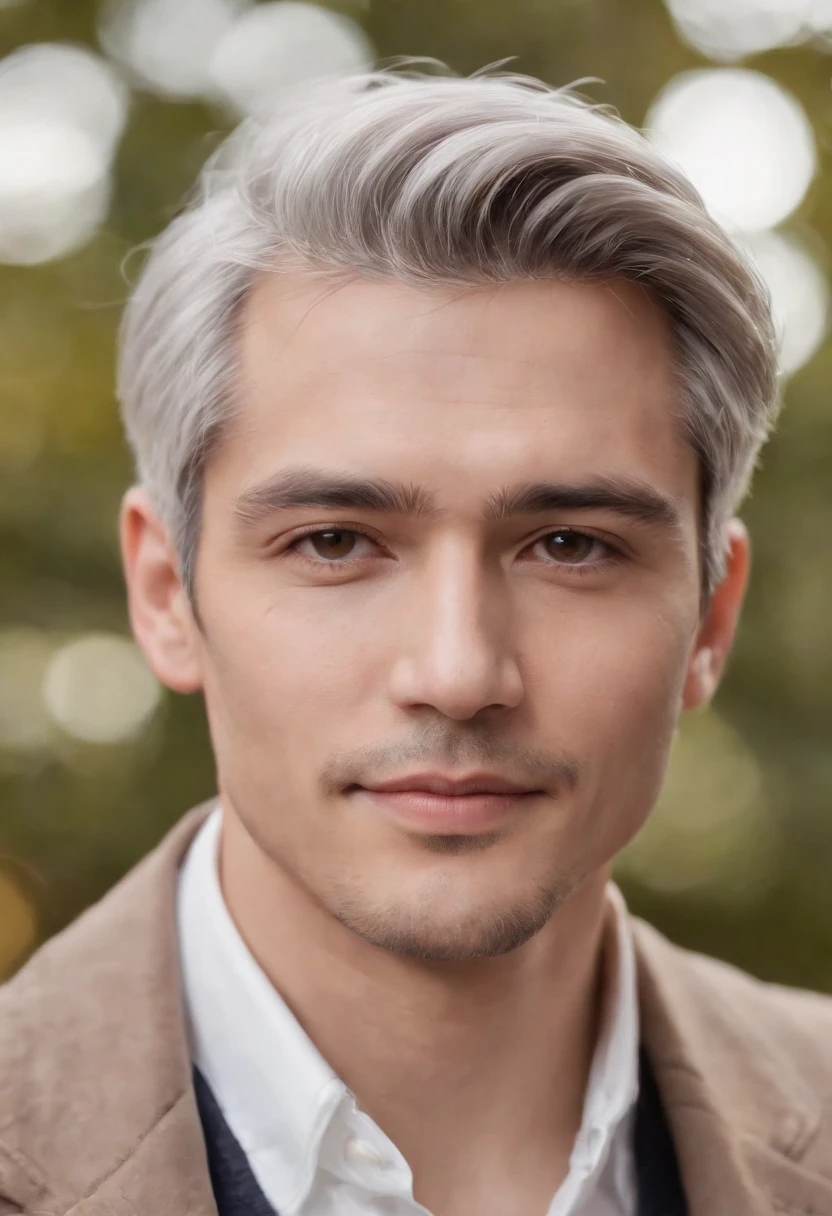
220,812,608,1212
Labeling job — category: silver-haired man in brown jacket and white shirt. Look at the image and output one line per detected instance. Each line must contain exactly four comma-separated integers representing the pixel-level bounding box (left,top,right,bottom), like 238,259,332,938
0,73,832,1216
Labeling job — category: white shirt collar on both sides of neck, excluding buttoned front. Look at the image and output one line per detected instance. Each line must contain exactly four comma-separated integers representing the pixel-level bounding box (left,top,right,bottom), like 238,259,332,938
178,805,639,1209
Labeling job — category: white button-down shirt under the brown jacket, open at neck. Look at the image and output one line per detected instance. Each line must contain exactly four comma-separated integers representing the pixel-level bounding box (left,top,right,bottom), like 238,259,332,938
178,805,639,1216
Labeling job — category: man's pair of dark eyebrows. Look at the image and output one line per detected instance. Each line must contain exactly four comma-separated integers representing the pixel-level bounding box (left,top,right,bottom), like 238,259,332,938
228,466,681,531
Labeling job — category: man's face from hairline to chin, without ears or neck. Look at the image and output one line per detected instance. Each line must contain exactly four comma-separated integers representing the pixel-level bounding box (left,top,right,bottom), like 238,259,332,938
133,277,729,958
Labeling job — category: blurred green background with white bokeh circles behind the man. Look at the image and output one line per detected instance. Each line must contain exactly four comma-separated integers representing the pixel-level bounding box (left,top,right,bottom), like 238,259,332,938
0,0,832,992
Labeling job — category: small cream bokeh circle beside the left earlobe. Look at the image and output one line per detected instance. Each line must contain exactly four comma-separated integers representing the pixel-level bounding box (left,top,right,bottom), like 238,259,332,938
44,634,161,743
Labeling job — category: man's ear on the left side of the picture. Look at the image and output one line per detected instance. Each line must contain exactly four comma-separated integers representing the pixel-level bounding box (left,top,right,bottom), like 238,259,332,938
119,486,202,692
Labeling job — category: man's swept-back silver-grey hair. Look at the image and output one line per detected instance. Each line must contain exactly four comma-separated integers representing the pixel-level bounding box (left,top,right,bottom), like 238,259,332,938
118,71,778,596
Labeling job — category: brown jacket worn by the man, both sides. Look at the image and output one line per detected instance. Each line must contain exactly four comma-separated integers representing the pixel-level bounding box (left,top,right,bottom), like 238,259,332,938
0,807,832,1216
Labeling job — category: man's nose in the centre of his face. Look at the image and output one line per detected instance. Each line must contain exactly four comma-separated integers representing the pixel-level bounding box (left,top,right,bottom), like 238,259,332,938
390,546,523,720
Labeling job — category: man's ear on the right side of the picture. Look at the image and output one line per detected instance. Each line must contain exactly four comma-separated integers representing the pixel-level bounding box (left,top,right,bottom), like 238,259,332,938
682,519,751,709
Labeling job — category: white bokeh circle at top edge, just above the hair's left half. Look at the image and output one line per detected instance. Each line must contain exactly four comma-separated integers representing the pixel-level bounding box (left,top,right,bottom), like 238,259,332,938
210,0,373,114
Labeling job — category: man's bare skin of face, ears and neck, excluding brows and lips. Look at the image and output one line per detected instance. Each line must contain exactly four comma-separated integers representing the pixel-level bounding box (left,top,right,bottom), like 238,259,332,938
122,276,748,1216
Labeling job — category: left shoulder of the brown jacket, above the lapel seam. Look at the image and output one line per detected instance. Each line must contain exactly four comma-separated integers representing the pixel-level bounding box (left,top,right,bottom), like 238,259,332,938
0,807,207,1212
